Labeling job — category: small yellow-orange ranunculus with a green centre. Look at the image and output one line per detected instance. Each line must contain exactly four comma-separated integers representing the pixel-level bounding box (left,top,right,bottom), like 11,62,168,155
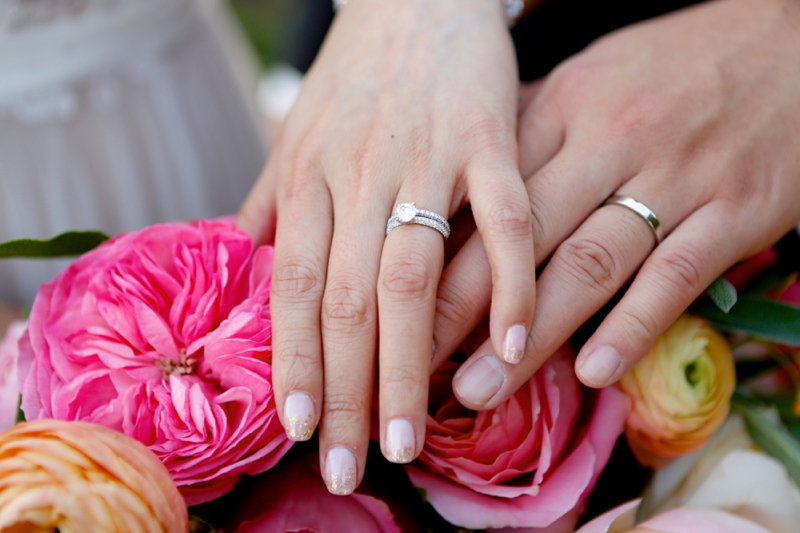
618,315,736,468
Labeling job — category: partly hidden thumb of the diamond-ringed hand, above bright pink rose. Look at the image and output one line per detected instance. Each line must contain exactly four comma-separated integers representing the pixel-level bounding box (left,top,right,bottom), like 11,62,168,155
236,137,281,246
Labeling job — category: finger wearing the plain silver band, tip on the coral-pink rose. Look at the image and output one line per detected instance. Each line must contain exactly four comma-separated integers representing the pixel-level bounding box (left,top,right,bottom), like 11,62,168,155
454,176,694,408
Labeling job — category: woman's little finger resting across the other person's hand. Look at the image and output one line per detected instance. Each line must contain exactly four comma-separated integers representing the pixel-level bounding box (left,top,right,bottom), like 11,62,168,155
467,154,535,364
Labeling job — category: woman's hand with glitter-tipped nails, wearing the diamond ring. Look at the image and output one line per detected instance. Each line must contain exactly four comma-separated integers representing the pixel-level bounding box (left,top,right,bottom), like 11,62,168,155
239,0,534,494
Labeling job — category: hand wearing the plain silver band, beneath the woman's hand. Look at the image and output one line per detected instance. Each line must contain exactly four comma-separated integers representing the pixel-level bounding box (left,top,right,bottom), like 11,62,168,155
434,0,800,409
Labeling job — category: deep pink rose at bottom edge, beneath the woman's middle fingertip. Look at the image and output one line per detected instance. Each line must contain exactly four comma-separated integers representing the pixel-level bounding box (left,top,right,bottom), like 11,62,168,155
226,454,406,533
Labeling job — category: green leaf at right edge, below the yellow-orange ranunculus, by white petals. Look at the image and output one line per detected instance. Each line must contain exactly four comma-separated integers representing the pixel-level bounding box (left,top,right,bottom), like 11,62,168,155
734,399,800,485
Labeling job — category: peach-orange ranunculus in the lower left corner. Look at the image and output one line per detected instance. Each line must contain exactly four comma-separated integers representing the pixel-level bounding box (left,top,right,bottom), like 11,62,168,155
0,420,189,533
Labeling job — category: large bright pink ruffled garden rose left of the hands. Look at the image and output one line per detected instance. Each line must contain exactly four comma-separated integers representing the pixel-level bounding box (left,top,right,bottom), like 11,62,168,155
20,221,291,505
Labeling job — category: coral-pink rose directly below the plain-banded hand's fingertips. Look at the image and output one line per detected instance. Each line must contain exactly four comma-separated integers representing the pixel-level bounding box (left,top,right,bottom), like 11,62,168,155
406,346,630,532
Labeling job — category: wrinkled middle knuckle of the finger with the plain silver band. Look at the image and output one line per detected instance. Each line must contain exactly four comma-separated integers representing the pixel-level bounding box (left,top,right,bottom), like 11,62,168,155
553,236,619,293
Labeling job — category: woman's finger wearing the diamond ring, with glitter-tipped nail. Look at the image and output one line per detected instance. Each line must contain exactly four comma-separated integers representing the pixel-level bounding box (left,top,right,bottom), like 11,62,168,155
378,197,449,463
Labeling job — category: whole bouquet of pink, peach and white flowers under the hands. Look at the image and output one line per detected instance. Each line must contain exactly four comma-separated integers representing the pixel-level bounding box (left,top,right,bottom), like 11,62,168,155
0,220,800,533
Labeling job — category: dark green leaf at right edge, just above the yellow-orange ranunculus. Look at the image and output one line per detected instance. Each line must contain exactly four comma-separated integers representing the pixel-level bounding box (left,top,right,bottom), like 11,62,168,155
693,294,800,346
